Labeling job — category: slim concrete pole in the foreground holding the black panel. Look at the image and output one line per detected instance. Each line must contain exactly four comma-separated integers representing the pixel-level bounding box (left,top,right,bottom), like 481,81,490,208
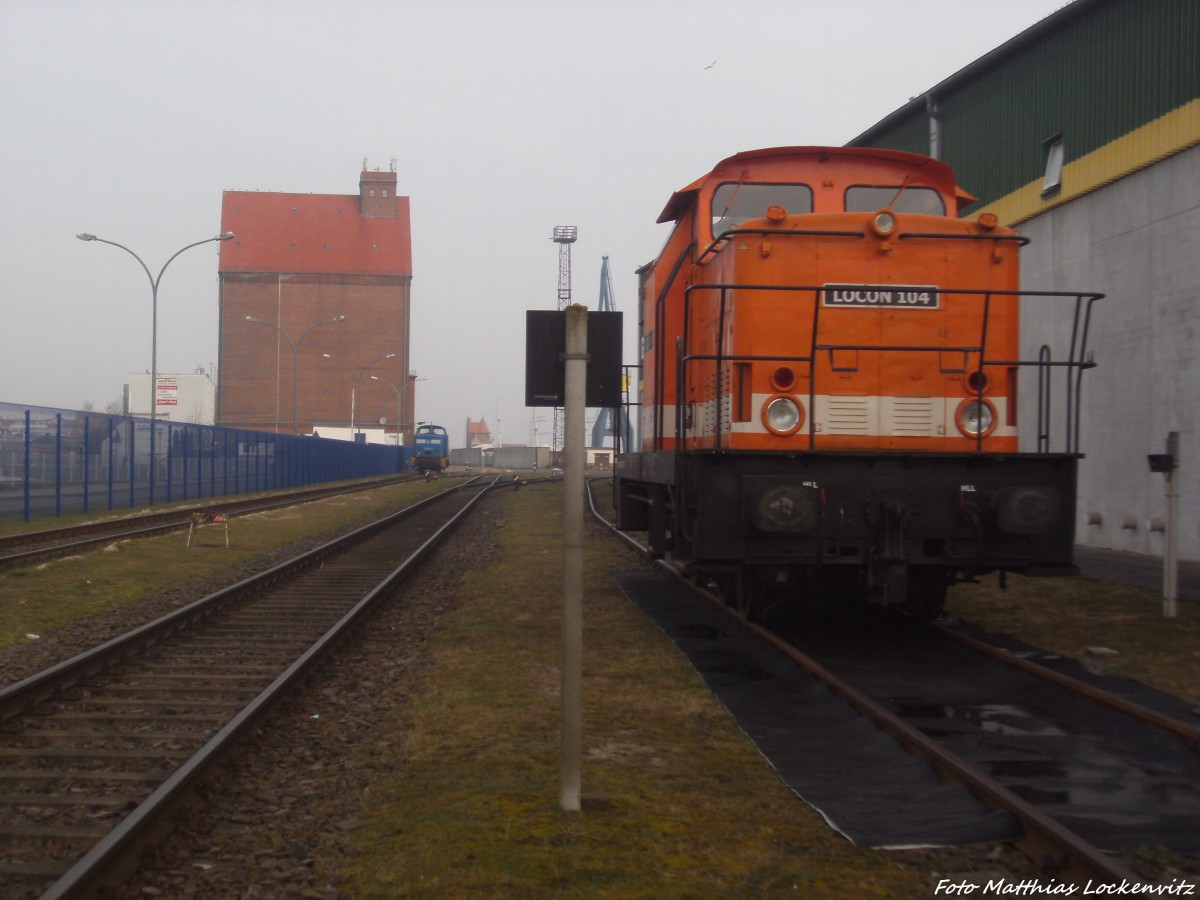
559,304,588,812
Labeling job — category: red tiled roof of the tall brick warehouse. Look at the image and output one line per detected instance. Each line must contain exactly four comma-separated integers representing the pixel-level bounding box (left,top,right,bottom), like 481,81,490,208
220,191,413,275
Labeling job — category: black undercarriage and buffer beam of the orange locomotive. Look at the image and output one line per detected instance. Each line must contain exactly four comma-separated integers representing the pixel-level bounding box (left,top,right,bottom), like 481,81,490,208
617,451,1079,617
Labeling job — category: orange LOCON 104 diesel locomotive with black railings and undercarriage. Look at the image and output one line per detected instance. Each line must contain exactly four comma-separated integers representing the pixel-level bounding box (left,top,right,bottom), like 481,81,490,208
616,148,1099,616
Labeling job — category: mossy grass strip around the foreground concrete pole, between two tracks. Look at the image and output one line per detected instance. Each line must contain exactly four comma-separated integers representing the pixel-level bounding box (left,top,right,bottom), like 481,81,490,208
340,485,929,898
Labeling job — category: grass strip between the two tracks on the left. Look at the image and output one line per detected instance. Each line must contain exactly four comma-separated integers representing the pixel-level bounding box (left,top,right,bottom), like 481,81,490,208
0,481,445,648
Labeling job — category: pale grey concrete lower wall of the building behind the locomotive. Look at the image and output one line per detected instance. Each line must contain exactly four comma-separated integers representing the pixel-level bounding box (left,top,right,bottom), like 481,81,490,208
1020,148,1200,559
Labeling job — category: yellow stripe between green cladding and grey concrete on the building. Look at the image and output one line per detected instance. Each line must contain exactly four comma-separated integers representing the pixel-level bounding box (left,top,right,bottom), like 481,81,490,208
972,98,1200,226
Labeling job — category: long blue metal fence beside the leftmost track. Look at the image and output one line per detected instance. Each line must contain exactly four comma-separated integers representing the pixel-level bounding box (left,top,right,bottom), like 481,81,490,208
0,403,412,522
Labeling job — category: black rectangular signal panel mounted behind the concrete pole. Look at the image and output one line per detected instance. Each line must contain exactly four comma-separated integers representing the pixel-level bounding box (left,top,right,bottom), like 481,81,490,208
526,310,623,408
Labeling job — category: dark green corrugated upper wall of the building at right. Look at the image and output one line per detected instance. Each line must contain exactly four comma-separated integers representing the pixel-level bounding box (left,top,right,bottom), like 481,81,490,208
854,0,1200,211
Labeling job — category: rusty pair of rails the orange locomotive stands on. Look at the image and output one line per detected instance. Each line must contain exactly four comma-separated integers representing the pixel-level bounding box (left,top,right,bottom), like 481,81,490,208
589,485,1200,886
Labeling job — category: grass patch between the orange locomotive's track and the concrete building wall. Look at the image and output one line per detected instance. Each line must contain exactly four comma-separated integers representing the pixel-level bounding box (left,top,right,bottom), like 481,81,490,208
946,575,1200,706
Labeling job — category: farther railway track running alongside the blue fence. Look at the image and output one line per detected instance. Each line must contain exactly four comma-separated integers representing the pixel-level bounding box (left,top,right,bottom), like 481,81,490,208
0,475,421,571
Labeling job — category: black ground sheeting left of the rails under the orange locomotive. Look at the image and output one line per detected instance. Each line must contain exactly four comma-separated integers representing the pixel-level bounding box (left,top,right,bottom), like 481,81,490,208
617,571,1020,847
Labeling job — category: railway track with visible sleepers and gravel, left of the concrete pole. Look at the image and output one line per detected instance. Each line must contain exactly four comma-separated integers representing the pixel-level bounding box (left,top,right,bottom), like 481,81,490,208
0,480,511,898
